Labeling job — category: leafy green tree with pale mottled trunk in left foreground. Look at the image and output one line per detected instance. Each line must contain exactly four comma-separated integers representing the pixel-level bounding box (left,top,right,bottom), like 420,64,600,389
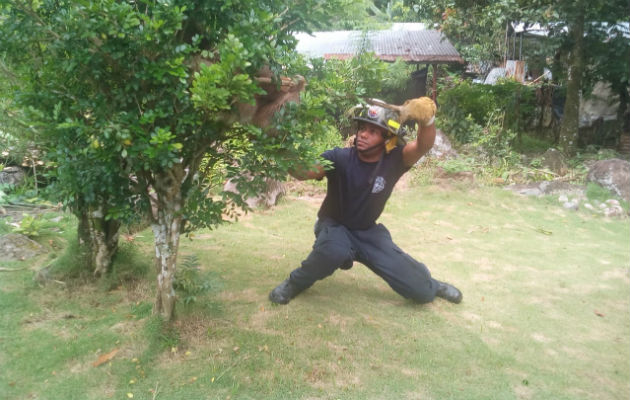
0,0,350,319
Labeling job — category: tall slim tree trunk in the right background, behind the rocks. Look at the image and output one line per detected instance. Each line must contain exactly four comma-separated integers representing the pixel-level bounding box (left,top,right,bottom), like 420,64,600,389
559,8,584,155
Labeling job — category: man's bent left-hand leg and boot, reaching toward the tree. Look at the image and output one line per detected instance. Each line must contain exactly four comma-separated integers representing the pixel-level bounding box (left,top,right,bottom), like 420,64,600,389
269,220,354,304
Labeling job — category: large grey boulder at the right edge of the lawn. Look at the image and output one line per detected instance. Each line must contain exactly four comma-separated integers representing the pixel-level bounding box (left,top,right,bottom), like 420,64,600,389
586,158,630,202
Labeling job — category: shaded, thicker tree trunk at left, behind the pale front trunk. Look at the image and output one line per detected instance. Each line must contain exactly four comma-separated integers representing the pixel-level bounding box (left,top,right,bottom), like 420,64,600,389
77,207,120,276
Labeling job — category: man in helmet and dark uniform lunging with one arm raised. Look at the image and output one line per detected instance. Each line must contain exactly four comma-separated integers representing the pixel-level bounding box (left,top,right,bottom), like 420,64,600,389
269,99,462,304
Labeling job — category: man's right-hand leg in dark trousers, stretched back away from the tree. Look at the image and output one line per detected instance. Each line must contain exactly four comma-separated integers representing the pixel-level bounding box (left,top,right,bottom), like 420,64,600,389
352,224,461,303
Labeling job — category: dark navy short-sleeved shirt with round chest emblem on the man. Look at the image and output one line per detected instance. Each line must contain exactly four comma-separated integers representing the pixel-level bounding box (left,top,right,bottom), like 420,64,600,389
317,146,409,230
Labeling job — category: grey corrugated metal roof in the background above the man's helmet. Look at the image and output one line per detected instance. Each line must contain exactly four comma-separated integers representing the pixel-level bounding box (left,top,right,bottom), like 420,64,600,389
296,25,464,64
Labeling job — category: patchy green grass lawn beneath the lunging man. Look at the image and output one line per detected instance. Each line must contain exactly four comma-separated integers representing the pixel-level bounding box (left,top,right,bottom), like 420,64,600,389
0,186,630,400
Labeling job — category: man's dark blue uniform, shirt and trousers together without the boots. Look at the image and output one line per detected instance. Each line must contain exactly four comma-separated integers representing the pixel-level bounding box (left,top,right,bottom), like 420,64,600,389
290,146,439,303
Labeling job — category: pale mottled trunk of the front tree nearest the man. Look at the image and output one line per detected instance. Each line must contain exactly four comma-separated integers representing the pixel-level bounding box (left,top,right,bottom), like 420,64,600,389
151,166,185,321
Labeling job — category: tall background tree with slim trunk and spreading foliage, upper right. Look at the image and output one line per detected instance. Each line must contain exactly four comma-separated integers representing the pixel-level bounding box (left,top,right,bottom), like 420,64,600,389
411,0,630,154
